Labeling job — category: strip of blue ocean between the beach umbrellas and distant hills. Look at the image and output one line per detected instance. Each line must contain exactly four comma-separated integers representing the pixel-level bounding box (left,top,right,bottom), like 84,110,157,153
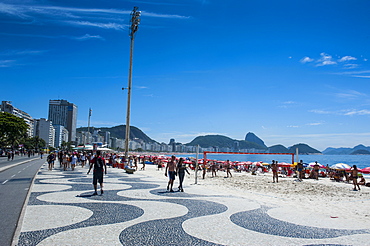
178,153,370,168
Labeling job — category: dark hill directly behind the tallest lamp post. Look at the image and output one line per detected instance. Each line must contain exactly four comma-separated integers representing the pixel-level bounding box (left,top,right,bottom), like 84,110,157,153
77,125,156,143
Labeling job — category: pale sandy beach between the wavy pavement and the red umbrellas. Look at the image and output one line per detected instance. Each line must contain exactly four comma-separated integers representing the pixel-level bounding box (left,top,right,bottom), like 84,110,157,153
136,165,370,229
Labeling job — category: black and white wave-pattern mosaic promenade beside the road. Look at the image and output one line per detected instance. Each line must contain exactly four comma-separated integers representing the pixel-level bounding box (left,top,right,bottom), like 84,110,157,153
18,165,370,246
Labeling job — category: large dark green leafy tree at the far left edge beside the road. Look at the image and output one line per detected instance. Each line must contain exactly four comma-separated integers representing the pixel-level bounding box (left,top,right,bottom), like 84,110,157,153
0,112,28,148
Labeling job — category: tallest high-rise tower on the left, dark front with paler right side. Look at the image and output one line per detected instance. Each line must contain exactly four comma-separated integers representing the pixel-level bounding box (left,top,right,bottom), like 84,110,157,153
48,100,77,142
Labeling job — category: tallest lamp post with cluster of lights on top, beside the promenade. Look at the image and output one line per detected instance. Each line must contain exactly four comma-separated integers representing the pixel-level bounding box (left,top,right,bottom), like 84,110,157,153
125,7,141,160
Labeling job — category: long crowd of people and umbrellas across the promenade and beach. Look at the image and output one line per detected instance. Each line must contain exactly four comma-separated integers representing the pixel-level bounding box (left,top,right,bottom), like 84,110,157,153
41,151,370,193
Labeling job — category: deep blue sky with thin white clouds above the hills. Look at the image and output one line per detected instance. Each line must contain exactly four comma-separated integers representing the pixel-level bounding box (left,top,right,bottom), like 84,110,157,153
0,0,370,150
